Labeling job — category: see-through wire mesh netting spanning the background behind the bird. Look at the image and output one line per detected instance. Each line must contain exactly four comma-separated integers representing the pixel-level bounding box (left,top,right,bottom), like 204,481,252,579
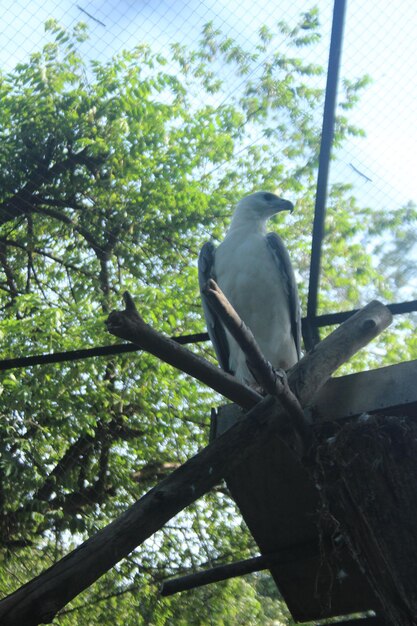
0,0,417,624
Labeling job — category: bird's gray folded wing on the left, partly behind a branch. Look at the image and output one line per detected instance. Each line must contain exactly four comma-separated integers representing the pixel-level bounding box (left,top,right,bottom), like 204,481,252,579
198,241,230,373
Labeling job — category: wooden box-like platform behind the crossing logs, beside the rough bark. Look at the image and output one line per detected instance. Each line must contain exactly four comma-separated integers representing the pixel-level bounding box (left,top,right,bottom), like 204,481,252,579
212,361,417,624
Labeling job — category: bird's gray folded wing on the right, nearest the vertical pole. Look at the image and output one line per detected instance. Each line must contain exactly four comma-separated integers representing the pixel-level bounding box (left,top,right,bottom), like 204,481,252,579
266,233,301,359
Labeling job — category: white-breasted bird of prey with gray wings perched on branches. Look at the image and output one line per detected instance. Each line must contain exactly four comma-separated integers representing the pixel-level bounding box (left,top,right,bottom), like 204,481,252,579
198,191,301,387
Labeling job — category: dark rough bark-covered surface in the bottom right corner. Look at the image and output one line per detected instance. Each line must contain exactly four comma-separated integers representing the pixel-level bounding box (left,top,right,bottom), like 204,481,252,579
316,415,417,626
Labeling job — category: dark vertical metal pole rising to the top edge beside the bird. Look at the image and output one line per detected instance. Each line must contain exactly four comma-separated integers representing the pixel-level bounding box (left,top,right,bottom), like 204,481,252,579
303,0,347,350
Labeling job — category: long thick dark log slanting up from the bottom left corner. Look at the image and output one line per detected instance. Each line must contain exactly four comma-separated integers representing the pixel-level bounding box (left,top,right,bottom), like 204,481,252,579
0,396,300,626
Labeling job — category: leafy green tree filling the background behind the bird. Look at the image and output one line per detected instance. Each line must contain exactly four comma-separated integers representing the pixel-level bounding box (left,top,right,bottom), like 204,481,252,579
0,11,415,624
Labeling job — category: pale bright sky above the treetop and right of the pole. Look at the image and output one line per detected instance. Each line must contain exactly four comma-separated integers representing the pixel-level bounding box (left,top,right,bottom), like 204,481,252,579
0,0,417,210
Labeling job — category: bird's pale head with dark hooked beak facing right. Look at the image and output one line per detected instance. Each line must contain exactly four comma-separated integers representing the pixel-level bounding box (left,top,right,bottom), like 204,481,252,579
231,191,294,227
